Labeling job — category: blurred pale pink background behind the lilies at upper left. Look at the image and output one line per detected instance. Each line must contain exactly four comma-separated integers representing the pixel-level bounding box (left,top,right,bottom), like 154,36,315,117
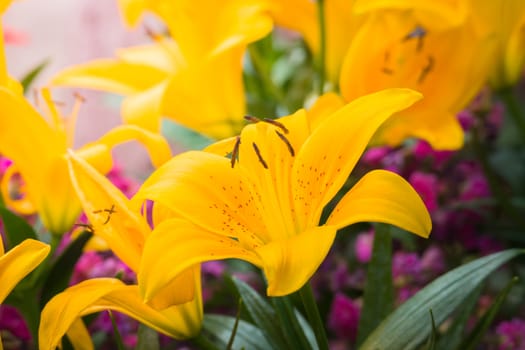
3,0,160,179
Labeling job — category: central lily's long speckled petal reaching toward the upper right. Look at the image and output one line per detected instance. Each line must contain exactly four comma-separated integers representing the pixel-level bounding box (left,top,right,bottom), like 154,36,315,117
292,89,421,229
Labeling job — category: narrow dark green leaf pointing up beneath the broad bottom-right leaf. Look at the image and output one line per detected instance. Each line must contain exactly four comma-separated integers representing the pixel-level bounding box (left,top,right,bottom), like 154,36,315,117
436,287,481,350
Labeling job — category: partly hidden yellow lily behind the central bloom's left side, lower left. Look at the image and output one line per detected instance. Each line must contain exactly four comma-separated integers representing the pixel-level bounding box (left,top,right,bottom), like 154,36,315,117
39,153,202,350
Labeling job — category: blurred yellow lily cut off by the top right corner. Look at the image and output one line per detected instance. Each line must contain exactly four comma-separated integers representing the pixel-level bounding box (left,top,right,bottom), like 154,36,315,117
472,0,525,89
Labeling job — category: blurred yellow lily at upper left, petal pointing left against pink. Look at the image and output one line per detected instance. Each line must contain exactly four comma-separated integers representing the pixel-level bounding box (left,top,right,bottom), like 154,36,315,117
51,0,272,138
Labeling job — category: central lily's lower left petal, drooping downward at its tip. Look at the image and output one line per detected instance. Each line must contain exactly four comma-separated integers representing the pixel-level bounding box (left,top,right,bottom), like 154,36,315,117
138,219,261,301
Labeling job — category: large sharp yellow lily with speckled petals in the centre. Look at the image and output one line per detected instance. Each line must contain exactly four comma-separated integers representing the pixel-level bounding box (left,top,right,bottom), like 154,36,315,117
133,89,431,296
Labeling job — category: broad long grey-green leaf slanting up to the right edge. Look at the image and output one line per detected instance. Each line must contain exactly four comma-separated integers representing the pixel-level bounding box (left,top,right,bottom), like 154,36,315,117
360,249,524,350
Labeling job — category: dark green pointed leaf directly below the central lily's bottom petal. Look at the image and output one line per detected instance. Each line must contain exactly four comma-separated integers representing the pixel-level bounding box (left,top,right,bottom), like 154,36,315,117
232,277,287,349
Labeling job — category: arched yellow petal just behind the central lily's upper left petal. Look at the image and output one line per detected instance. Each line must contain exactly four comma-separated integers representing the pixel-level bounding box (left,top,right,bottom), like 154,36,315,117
87,125,171,167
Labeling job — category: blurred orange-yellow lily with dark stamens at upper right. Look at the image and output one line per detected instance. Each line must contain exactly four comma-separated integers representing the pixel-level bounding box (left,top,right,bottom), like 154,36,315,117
339,6,491,150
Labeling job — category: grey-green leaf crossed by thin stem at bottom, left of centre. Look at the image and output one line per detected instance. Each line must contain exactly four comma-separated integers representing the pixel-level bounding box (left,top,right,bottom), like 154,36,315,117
202,314,274,350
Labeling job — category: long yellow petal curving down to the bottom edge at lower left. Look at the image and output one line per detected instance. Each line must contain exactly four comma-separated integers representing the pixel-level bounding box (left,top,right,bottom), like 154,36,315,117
39,278,202,350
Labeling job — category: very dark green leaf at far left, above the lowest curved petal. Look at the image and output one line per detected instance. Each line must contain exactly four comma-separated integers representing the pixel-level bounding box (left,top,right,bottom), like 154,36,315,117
40,231,92,308
